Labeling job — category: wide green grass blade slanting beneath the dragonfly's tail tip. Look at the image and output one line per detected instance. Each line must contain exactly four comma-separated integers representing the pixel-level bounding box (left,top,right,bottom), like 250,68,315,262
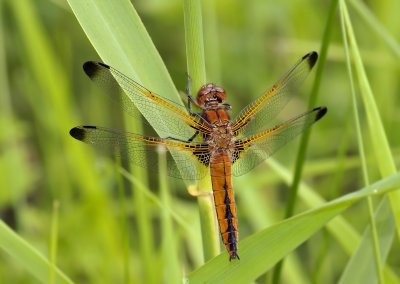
188,174,400,283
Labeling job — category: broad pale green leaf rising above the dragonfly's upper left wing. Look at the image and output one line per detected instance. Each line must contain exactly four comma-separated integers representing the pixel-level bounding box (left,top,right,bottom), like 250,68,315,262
68,0,179,108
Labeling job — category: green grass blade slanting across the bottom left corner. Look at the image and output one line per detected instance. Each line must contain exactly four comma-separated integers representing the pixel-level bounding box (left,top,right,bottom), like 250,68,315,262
0,220,73,284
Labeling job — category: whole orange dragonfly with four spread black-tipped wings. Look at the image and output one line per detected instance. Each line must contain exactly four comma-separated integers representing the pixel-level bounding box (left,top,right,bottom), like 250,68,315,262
70,51,327,260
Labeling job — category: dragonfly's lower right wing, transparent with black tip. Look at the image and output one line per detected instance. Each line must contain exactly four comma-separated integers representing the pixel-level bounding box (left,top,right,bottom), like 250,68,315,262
233,107,327,176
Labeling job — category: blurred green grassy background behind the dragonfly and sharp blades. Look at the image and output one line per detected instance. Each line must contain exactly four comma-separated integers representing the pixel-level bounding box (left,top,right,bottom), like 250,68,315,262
0,0,400,283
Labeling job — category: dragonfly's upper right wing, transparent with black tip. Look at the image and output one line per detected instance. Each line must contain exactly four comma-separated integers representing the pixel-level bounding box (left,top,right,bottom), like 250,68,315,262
233,52,318,139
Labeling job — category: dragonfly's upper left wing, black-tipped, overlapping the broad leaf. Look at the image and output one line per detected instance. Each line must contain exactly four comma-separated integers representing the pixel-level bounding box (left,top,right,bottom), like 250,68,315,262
83,61,209,140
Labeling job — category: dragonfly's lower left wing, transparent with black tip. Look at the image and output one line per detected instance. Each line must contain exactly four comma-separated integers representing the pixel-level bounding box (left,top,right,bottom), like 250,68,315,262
70,126,210,180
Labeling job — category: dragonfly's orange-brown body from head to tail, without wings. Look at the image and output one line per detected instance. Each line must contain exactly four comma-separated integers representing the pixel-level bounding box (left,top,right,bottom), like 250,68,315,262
198,84,239,259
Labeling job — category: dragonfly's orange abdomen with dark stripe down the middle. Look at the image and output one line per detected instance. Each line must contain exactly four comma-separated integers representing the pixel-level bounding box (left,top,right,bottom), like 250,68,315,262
210,153,239,259
